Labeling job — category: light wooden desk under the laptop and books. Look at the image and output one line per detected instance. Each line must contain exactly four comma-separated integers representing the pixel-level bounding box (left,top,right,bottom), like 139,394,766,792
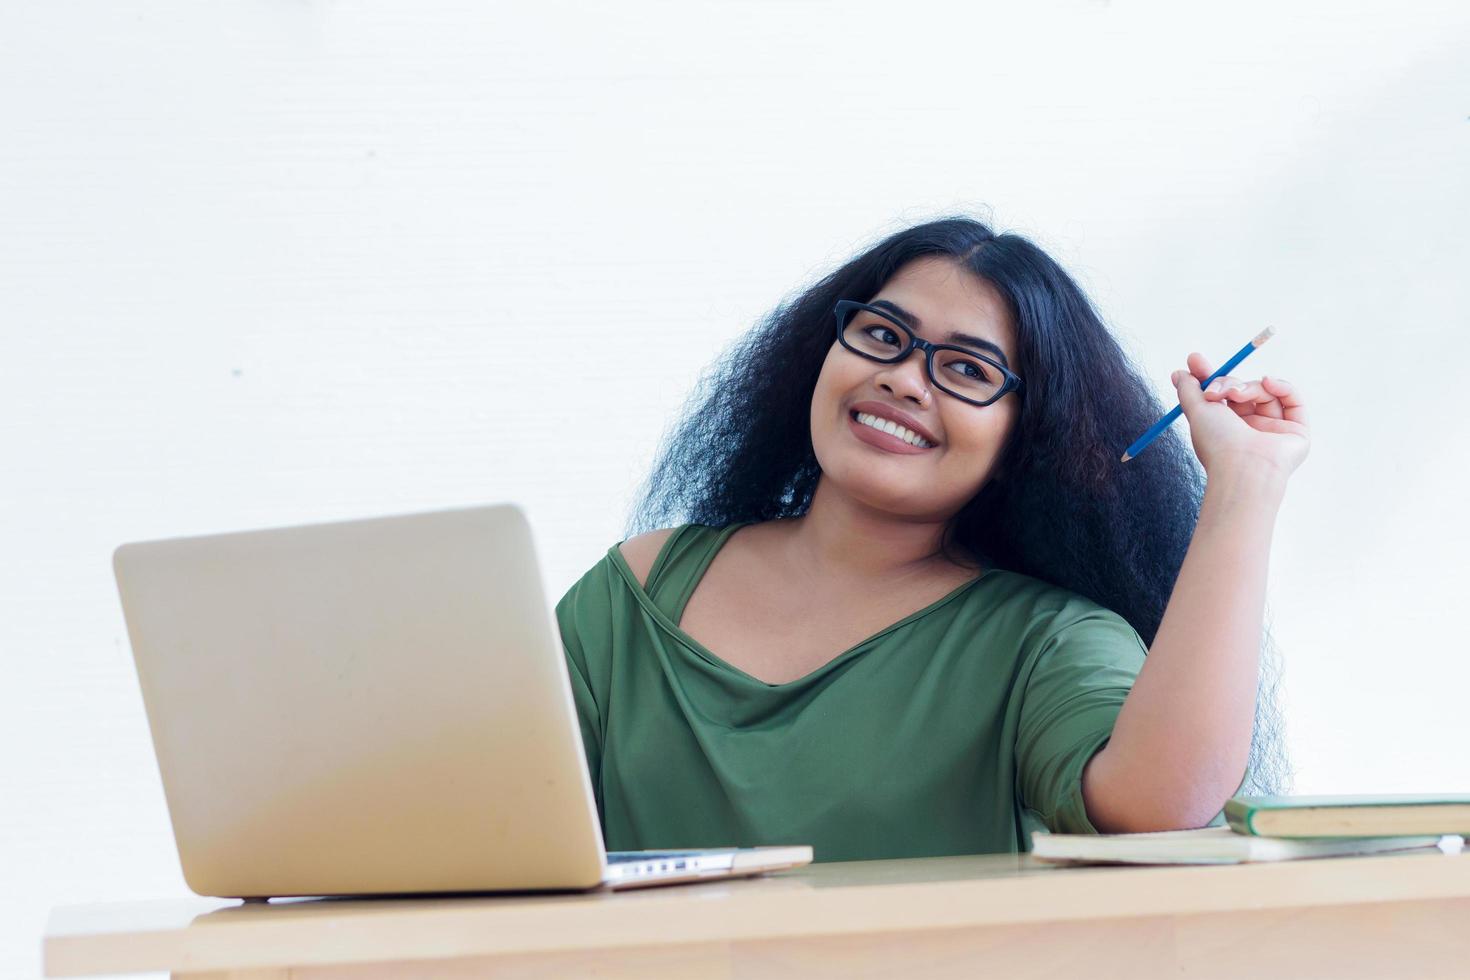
44,851,1470,980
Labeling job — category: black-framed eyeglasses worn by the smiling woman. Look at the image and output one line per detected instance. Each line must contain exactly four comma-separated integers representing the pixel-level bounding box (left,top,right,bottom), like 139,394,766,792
833,300,1023,407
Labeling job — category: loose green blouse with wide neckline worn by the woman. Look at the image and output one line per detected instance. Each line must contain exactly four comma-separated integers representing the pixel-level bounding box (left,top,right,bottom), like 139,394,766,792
556,525,1220,861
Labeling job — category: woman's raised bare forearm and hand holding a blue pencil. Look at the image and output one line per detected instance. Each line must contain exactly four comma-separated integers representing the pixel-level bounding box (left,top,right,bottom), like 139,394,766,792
1082,354,1308,833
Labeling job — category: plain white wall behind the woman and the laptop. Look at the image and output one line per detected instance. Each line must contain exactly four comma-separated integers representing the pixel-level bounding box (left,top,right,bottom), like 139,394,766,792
0,0,1470,977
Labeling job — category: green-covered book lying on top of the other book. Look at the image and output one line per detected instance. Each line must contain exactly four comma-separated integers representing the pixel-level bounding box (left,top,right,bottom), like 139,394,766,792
1225,793,1470,837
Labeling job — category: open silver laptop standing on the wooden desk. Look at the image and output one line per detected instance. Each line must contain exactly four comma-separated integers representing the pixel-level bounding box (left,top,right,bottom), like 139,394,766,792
113,504,811,899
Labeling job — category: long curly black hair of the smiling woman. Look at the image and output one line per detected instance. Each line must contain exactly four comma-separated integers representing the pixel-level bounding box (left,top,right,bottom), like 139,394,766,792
626,216,1291,793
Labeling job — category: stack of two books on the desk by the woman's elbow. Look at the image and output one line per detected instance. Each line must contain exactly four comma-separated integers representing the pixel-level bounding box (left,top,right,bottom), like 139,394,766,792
1030,795,1470,864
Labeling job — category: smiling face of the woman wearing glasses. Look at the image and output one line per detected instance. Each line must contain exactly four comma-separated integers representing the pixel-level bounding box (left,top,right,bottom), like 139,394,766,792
811,256,1020,520
